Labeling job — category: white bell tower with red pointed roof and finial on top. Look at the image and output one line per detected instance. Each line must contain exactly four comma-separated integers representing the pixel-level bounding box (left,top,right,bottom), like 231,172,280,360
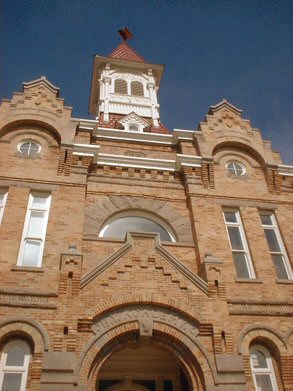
89,28,168,133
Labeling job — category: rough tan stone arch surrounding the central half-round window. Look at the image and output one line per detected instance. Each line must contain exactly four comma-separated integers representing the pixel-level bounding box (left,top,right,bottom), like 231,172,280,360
84,195,193,242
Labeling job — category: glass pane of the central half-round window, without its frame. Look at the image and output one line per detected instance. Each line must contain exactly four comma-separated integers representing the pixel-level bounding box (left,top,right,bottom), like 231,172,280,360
103,217,172,242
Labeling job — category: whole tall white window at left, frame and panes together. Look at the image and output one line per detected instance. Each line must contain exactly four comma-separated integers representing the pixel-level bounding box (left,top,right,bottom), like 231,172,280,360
18,193,51,267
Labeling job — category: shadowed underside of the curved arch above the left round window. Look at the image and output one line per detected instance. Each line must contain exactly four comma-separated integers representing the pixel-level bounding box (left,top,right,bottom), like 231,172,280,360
0,117,61,145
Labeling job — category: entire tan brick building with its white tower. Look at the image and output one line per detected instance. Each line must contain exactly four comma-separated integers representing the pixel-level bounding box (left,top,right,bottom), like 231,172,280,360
0,37,293,391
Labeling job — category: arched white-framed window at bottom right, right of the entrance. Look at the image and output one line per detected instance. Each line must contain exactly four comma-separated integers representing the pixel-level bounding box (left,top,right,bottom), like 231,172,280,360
250,345,278,391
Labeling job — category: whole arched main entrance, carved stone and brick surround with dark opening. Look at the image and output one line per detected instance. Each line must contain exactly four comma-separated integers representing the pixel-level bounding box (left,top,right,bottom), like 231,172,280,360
74,303,216,391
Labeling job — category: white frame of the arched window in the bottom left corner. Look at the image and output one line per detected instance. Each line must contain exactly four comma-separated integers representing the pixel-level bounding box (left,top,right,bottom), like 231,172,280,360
0,340,31,391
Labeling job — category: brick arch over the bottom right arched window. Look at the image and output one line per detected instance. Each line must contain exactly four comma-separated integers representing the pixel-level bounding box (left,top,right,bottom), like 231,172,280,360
237,325,287,356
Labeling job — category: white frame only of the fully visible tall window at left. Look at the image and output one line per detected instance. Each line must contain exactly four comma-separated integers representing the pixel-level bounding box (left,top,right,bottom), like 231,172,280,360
17,192,51,267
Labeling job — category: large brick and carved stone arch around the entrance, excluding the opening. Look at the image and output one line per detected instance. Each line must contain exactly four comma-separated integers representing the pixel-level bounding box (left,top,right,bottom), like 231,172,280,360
74,305,216,389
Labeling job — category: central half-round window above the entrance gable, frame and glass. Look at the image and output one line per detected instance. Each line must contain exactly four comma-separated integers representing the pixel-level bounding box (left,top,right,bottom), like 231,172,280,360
99,211,176,242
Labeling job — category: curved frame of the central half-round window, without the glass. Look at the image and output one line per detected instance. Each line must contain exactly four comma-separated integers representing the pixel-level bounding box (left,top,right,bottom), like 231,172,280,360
99,209,177,242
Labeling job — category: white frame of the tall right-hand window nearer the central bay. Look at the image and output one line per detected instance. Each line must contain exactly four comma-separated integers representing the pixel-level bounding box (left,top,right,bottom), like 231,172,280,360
223,208,256,279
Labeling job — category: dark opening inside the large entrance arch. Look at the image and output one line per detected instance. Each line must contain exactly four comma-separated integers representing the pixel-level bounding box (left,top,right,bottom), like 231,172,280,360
96,345,190,391
